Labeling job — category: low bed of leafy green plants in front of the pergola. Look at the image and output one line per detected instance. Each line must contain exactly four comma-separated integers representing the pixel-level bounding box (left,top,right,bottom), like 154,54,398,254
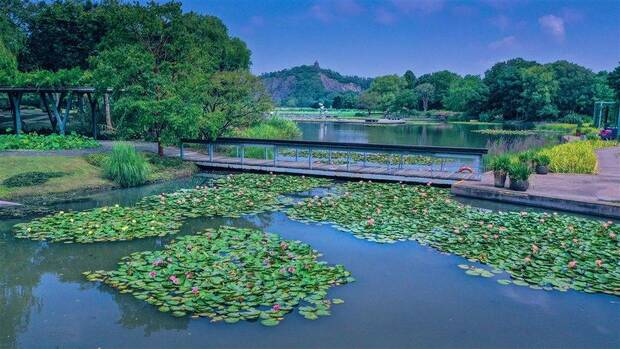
0,133,100,151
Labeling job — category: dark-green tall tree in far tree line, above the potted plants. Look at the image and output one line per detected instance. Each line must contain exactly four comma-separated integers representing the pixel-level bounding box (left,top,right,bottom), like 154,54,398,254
483,58,538,120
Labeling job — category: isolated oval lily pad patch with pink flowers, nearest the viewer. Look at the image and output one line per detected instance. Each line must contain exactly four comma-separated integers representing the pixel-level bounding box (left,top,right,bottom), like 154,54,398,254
84,227,354,326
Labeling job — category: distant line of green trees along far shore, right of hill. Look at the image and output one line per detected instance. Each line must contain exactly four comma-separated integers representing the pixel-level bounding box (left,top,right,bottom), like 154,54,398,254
332,58,620,120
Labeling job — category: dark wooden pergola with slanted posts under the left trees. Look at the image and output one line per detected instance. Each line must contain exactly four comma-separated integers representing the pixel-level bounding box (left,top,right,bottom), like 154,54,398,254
0,87,112,138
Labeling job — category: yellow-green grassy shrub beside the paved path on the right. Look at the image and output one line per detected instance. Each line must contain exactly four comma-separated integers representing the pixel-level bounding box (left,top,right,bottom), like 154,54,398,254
540,140,618,174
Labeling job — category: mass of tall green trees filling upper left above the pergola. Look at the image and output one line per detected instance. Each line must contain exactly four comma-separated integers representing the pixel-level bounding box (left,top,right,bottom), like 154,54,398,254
0,0,272,151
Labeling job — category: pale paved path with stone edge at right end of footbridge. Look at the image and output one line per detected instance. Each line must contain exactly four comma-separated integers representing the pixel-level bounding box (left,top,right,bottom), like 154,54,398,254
452,147,620,218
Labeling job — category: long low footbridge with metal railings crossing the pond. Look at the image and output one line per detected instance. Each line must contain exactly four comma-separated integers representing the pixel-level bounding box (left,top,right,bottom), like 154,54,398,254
182,138,486,184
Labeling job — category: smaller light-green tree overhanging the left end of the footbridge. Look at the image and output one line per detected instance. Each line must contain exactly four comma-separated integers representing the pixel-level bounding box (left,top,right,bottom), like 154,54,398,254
190,70,272,139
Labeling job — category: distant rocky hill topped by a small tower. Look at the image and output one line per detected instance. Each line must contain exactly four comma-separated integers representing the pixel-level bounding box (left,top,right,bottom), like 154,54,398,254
261,62,371,107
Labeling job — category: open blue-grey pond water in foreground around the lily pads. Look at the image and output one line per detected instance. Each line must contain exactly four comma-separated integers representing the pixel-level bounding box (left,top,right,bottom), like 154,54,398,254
0,177,620,348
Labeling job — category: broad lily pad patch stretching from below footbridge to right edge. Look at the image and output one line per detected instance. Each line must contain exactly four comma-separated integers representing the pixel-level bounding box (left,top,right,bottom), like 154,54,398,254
289,182,620,295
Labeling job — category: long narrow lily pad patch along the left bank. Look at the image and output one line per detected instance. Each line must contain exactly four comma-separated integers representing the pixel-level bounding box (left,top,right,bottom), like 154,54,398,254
15,174,331,243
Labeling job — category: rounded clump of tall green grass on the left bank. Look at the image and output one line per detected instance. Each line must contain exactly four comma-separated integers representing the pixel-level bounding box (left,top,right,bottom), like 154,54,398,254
103,143,150,188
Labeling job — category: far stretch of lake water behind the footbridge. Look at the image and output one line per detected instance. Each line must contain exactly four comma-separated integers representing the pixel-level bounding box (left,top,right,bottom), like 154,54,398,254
297,122,557,148
